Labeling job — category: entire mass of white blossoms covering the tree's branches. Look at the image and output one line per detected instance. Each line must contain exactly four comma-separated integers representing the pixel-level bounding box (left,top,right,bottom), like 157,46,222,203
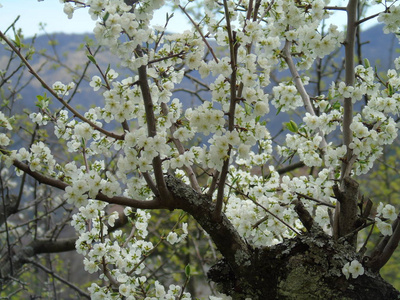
0,0,400,300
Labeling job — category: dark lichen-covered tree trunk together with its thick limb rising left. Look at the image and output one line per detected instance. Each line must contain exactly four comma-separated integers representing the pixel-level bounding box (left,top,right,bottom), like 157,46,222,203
166,176,400,300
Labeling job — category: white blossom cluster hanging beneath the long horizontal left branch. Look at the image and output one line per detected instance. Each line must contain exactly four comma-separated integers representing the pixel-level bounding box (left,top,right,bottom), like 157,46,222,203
72,200,175,299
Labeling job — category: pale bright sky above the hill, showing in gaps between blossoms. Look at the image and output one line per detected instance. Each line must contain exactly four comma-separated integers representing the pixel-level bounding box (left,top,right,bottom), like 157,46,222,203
0,0,382,37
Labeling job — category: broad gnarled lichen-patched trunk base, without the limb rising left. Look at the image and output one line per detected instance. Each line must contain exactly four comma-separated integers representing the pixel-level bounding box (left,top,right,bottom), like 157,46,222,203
208,231,400,300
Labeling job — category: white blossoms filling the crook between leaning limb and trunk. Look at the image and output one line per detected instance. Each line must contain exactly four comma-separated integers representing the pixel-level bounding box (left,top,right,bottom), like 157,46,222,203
226,167,334,246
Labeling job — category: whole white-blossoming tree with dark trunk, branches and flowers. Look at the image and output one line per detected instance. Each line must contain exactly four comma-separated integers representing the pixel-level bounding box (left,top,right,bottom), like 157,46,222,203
0,0,400,299
